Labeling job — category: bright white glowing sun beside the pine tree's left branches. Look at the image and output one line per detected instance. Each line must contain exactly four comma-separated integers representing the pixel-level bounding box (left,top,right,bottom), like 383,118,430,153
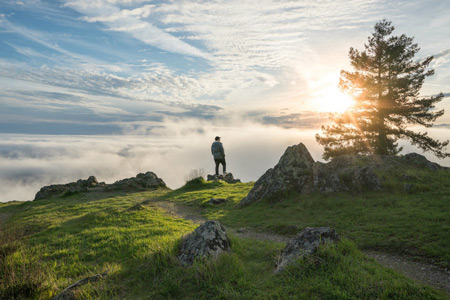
316,87,354,113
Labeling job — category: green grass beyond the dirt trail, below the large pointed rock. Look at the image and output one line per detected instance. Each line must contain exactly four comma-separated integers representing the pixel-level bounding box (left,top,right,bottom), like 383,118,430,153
163,170,450,267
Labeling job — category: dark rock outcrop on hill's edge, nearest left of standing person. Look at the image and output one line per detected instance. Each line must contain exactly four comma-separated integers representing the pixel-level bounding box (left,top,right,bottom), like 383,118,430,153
105,172,167,191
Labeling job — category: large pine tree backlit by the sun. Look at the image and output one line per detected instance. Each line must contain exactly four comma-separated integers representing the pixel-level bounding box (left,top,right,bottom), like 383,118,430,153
316,20,450,159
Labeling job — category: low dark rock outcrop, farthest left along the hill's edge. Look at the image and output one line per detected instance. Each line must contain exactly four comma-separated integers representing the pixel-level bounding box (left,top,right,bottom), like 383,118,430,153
34,176,105,200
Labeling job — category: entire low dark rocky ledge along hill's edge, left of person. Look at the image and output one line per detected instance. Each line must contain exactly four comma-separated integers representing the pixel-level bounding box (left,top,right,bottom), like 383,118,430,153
34,172,167,200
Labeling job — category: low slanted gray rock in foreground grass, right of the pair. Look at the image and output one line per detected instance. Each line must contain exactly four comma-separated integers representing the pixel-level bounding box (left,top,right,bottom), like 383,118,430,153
275,227,339,272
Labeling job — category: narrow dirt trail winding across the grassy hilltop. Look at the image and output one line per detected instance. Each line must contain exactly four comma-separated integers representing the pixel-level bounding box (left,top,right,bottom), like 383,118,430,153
143,199,450,294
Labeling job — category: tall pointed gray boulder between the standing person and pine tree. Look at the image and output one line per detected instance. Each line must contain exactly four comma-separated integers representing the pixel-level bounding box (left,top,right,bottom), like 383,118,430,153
239,143,314,206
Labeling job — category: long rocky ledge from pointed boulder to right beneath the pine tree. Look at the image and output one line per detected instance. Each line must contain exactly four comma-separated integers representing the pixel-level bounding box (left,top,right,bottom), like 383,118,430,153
239,143,445,207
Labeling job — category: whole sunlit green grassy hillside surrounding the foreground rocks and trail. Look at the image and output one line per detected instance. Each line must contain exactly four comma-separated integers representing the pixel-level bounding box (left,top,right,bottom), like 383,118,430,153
0,172,450,299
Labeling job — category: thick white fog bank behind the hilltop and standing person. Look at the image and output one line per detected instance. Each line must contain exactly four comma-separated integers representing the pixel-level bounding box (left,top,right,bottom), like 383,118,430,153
0,126,450,202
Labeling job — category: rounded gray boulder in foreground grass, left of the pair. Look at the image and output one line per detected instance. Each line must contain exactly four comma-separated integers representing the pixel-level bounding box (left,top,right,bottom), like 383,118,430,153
178,220,231,266
